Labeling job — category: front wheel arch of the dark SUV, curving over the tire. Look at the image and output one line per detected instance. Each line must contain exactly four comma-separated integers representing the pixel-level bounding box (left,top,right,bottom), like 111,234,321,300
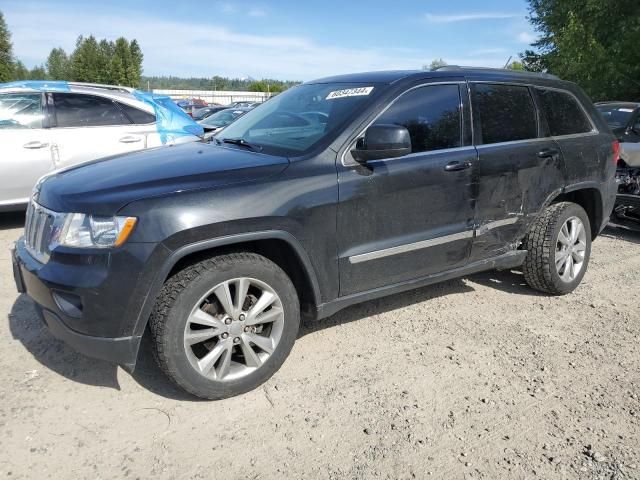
134,230,321,336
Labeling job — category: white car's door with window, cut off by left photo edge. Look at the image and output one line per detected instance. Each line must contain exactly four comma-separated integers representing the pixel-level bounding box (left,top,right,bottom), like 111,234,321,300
0,93,54,205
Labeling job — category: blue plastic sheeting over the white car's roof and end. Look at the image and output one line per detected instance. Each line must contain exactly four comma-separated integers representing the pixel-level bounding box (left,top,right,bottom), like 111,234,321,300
0,80,204,144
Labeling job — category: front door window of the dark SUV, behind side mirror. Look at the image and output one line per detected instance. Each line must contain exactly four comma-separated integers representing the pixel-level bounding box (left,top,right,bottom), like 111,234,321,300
374,85,462,153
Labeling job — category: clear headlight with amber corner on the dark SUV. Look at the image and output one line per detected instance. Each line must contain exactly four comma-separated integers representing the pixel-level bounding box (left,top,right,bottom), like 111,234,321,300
50,213,137,249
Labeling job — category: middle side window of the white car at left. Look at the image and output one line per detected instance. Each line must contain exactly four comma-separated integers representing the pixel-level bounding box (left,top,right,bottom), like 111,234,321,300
52,93,131,127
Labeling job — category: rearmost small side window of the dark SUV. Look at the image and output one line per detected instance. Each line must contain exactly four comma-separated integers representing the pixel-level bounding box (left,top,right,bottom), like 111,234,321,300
536,88,593,137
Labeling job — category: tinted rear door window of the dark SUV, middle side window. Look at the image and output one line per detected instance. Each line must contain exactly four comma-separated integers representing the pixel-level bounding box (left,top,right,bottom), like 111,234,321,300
473,84,538,144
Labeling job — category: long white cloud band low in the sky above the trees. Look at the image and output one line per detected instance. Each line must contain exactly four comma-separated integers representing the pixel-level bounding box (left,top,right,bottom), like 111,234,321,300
4,3,516,80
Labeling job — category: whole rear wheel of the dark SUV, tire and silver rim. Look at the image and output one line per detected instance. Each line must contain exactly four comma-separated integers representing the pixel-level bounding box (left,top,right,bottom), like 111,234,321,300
523,202,591,295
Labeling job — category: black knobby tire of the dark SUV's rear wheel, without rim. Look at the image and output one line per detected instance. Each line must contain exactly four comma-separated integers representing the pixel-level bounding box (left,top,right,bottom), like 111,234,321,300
522,202,591,295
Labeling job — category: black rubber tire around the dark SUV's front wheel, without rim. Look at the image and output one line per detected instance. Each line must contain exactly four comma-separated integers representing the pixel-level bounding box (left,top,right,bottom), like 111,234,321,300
149,253,300,400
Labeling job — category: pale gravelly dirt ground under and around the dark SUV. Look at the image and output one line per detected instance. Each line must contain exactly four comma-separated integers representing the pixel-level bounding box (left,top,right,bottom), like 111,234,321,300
0,214,640,479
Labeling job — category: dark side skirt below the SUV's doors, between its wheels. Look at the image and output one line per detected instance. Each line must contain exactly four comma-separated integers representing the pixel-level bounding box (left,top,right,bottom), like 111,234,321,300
315,250,527,319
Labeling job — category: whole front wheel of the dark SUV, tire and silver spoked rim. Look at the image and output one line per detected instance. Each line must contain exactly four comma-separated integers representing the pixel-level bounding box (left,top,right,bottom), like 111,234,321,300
150,253,300,399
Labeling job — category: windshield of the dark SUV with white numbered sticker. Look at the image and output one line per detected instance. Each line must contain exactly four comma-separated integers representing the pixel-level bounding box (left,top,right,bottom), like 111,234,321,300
215,83,382,156
